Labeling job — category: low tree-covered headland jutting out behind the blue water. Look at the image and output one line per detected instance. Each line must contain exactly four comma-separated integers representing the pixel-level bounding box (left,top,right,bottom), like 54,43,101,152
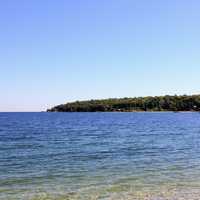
47,95,200,112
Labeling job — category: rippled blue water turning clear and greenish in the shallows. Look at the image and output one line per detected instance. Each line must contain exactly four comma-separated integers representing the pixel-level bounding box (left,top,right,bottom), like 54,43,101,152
0,112,200,200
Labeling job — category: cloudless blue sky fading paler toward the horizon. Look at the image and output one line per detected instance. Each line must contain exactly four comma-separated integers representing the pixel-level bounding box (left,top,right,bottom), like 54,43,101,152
0,0,200,111
